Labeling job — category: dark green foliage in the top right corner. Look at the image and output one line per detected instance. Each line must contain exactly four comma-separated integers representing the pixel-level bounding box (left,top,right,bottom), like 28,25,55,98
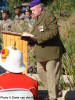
48,0,75,16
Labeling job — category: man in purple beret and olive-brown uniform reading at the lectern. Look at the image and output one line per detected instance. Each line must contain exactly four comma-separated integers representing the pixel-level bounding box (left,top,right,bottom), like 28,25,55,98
22,0,65,100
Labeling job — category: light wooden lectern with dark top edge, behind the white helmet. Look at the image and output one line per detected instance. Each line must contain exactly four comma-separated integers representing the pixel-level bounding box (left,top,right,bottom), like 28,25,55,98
2,31,27,74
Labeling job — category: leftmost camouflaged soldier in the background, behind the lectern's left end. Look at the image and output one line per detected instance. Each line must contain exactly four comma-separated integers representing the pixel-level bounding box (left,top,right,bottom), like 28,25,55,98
0,9,12,74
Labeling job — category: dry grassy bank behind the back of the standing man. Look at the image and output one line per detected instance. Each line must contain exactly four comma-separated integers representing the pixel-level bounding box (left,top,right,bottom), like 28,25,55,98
58,13,75,89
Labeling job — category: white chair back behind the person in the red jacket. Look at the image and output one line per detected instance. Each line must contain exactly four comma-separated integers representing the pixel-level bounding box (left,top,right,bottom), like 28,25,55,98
0,89,34,100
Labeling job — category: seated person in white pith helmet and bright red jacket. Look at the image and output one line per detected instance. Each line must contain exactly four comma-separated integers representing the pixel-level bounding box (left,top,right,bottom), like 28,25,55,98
0,46,38,100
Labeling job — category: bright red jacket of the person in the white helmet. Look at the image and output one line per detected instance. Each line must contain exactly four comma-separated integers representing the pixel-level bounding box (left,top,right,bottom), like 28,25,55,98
0,73,38,100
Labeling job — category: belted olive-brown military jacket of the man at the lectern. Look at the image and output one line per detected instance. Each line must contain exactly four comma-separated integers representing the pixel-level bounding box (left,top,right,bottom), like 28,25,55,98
32,10,65,62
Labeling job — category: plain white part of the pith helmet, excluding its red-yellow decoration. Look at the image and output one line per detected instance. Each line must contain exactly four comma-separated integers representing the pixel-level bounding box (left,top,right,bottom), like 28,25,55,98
0,47,25,73
